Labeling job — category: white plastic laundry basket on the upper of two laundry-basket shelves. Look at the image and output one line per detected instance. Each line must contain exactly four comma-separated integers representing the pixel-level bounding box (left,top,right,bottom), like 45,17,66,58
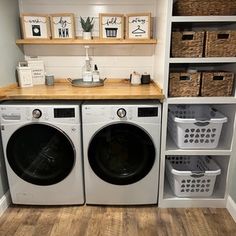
168,105,227,149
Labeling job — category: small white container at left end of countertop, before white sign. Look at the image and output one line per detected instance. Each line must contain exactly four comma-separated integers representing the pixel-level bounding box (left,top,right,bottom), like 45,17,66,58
16,62,33,87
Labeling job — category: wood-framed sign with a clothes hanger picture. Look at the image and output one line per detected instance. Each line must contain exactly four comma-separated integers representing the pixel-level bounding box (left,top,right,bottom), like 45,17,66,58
126,13,151,39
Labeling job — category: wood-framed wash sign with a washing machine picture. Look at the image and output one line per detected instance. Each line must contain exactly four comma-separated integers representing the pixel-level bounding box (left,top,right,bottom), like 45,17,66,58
21,14,50,39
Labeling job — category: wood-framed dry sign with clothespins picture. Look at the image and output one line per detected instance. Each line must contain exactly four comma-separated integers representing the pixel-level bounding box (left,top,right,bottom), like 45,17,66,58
50,13,75,39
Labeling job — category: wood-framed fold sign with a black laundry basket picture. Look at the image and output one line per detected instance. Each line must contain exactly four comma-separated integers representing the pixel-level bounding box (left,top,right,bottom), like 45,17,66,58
99,13,124,39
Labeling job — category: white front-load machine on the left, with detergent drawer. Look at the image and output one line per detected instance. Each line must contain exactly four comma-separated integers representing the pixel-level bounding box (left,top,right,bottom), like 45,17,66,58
0,103,84,205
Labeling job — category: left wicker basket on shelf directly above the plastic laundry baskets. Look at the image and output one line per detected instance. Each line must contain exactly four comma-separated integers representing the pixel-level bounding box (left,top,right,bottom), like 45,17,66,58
169,72,201,97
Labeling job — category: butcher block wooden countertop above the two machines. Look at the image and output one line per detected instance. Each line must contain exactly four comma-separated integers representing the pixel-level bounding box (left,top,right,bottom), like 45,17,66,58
0,79,164,100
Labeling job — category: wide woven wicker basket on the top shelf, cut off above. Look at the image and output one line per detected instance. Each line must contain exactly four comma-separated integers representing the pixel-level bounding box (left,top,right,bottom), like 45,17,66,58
174,0,236,16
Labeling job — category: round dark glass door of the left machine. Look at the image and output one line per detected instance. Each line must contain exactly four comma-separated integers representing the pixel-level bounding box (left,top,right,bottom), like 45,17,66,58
7,124,75,185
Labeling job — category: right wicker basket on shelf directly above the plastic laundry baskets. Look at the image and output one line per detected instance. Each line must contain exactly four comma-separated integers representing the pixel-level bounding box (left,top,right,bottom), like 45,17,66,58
201,72,234,96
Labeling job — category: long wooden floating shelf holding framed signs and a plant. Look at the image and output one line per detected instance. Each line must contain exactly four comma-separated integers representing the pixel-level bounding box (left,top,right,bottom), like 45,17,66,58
16,39,157,45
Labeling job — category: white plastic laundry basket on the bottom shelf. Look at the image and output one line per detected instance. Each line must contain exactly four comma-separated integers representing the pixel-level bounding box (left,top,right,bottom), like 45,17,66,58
166,156,221,197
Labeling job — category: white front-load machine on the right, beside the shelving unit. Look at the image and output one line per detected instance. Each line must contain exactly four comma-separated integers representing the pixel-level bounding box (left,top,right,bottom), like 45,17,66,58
82,101,161,205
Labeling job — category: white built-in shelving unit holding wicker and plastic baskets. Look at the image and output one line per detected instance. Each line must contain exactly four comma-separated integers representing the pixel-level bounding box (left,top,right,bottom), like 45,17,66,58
159,0,236,207
